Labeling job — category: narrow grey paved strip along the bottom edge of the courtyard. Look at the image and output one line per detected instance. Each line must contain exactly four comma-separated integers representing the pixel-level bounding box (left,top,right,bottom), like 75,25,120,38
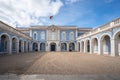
0,74,120,80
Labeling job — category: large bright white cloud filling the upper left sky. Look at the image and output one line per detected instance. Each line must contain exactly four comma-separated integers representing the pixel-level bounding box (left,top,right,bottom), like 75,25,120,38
0,0,63,26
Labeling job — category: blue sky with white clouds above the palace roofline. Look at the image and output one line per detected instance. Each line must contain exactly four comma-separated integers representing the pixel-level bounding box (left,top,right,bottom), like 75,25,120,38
0,0,120,28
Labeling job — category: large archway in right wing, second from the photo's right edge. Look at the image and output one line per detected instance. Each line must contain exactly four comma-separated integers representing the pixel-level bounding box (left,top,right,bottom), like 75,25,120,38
101,35,111,55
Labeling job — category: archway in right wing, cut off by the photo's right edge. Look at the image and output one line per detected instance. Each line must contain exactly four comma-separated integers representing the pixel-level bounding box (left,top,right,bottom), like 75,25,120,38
114,31,120,55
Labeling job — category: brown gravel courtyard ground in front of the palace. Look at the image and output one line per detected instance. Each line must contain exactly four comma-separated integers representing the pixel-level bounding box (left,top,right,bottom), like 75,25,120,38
0,52,120,80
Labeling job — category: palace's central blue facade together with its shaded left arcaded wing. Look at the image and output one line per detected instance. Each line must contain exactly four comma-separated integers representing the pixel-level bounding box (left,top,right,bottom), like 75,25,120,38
0,22,91,54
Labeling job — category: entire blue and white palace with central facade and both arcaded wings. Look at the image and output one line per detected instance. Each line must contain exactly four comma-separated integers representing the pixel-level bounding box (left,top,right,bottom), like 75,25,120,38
0,18,120,56
